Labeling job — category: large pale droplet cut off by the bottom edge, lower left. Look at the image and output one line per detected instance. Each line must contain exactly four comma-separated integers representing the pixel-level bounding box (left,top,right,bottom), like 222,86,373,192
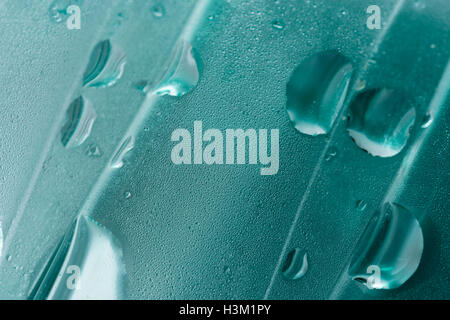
29,216,125,300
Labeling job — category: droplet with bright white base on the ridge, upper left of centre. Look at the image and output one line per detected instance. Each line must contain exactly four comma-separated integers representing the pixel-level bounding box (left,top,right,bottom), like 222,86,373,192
154,40,200,97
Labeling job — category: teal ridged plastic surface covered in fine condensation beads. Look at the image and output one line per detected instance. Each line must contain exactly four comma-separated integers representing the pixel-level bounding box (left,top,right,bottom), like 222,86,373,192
0,0,450,299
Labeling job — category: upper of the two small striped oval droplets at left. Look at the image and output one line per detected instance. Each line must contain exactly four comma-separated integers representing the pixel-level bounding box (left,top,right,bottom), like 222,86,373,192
83,40,126,88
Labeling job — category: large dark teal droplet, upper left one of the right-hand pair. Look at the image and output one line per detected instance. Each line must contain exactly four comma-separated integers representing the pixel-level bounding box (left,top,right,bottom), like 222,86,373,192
286,51,353,136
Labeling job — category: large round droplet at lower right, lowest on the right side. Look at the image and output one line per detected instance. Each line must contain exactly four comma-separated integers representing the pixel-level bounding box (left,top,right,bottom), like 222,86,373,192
349,203,423,289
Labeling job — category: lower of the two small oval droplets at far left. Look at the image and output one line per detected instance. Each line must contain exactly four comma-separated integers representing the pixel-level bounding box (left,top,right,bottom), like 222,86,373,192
61,96,97,148
